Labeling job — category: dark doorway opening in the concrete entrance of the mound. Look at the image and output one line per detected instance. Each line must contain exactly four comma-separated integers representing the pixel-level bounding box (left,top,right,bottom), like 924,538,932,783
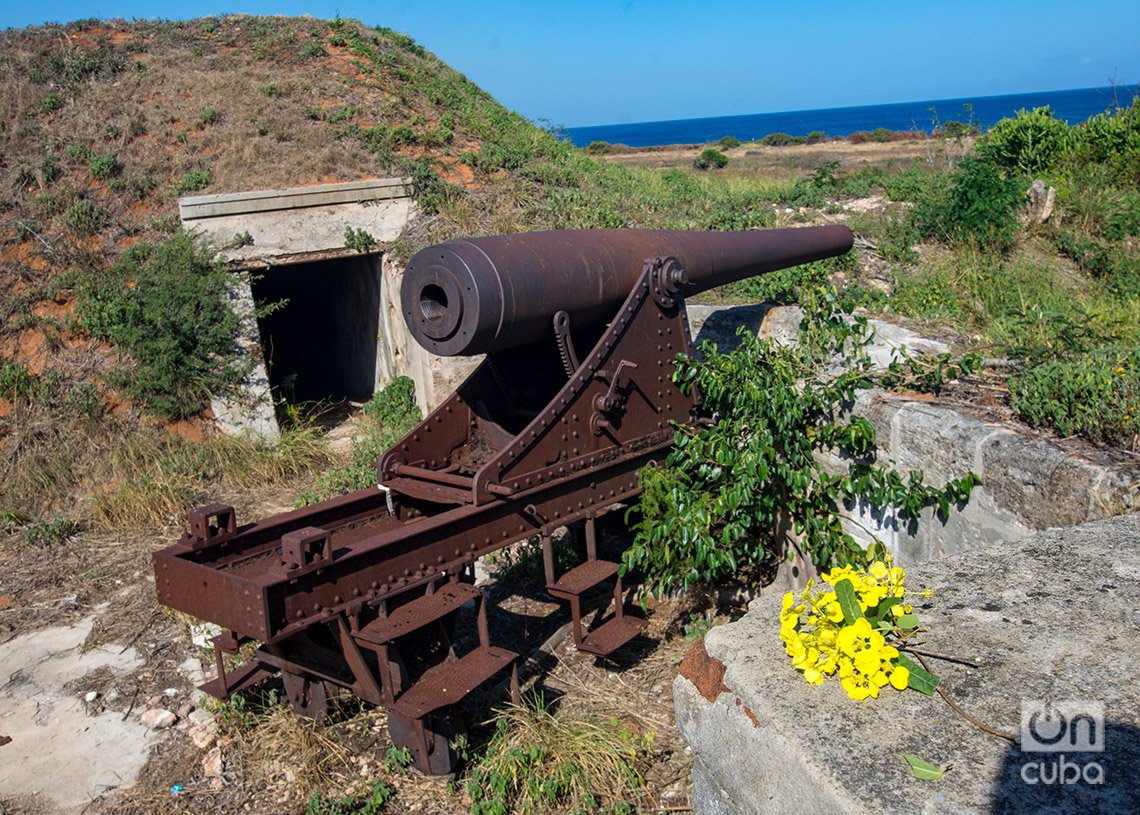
252,255,381,404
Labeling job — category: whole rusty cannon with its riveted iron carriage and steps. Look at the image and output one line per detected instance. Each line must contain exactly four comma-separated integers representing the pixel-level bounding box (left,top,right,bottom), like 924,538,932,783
154,226,852,774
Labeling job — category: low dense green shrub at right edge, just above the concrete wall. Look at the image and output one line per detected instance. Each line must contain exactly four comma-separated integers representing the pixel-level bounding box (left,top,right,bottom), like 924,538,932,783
1009,348,1140,447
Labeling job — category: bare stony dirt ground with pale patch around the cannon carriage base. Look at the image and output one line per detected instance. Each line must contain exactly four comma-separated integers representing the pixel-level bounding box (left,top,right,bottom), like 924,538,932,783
0,474,708,815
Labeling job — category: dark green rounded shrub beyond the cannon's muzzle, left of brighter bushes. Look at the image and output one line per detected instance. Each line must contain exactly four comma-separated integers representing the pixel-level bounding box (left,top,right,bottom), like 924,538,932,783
912,156,1025,251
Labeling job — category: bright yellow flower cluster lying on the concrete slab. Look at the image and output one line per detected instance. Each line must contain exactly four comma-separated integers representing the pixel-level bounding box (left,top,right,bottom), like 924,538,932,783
780,561,912,699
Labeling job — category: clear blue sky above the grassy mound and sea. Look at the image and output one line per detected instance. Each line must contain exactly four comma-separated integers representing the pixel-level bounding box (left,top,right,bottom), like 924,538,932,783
0,0,1140,127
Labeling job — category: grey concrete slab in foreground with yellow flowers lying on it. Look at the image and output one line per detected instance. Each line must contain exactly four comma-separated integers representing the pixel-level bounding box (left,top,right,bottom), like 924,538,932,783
674,515,1140,815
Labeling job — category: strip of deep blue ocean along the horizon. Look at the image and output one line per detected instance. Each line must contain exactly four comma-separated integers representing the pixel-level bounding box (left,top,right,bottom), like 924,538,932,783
567,88,1137,147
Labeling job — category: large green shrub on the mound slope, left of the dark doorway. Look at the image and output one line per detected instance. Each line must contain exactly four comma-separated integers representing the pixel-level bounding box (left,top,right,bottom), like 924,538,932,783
75,233,247,419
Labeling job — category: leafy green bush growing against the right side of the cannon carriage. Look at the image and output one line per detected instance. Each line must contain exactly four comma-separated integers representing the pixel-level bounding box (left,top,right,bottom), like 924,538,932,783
624,286,980,593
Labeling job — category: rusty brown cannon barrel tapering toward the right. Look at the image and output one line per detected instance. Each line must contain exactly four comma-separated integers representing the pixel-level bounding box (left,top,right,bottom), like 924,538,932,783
400,226,853,357
